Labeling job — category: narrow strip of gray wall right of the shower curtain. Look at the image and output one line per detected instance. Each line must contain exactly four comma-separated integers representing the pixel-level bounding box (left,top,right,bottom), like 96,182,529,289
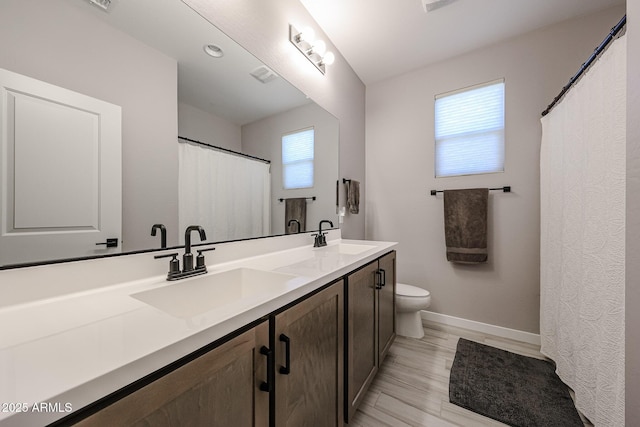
625,0,640,426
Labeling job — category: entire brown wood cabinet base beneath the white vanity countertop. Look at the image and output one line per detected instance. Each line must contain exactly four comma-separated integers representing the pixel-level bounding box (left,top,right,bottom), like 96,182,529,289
76,251,396,427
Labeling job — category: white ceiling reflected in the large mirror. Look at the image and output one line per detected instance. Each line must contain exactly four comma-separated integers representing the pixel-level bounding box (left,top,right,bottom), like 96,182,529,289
79,0,311,125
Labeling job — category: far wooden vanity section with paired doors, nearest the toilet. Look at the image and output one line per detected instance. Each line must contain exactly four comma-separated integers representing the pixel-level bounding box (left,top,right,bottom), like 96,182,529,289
345,251,396,422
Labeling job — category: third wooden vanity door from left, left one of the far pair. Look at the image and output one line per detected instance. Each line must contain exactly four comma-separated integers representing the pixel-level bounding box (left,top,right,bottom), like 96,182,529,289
346,261,378,420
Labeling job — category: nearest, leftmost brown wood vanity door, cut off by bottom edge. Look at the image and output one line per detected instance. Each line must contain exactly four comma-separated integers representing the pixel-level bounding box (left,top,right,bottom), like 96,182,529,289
78,322,269,427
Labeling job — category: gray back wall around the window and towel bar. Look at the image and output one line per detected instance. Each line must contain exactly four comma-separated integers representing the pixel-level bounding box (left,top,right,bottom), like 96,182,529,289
366,7,625,333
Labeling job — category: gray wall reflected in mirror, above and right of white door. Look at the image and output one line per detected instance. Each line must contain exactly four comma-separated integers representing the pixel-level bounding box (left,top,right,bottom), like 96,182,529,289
0,0,178,251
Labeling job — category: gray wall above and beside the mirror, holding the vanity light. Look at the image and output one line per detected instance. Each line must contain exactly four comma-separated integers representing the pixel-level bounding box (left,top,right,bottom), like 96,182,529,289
183,0,366,239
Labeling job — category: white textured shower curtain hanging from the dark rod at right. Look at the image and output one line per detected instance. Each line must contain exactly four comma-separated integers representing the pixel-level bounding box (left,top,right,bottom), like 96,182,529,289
540,37,626,427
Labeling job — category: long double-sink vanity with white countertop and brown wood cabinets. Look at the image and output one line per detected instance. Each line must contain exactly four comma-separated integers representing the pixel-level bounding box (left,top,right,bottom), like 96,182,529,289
0,230,396,426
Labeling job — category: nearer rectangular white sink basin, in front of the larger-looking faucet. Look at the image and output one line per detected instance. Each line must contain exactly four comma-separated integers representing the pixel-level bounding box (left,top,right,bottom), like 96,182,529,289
131,268,296,318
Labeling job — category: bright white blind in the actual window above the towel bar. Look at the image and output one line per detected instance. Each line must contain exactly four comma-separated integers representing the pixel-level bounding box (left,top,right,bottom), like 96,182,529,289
435,79,504,177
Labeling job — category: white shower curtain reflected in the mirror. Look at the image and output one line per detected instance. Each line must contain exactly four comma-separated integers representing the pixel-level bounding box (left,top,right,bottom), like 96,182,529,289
178,143,271,244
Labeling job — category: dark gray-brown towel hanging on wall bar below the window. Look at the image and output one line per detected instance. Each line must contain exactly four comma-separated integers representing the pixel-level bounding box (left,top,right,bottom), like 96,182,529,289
444,188,489,264
